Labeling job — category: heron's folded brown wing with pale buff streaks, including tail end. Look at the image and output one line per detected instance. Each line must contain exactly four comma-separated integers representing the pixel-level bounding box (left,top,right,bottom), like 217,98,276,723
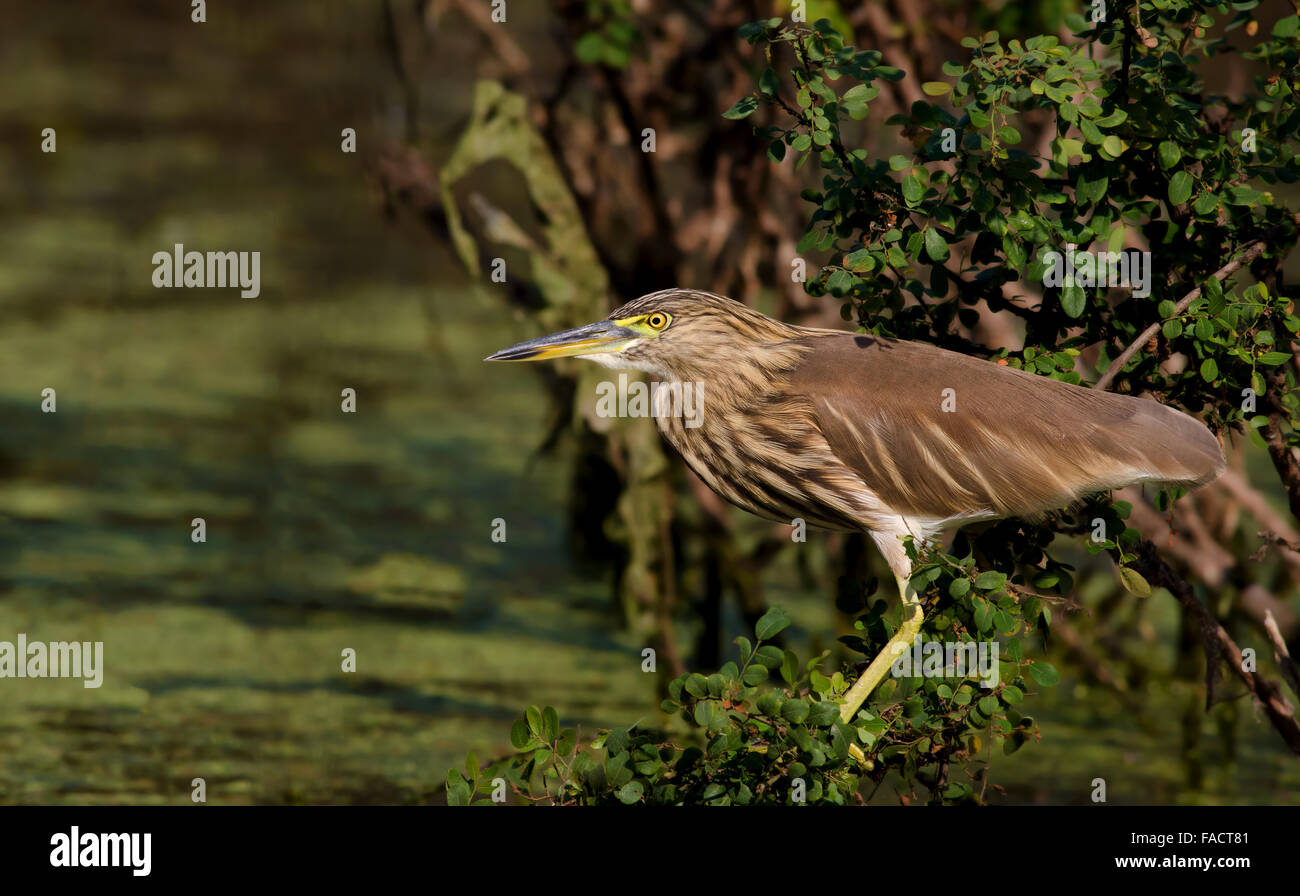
789,334,1223,520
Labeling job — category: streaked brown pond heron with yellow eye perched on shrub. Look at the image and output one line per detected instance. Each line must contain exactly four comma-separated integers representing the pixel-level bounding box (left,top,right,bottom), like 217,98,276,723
486,289,1225,722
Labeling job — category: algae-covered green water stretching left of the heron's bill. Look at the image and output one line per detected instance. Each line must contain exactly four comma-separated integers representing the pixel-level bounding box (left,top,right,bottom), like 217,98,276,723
0,4,653,802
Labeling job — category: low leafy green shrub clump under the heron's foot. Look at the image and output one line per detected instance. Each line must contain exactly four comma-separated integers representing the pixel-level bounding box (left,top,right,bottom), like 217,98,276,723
447,600,1057,805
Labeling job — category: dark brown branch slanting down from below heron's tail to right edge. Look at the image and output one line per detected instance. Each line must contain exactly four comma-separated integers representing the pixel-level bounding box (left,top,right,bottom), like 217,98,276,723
1132,538,1300,757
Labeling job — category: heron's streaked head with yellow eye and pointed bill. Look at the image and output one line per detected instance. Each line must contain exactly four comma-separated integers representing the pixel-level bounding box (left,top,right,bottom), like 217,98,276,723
485,289,796,380
